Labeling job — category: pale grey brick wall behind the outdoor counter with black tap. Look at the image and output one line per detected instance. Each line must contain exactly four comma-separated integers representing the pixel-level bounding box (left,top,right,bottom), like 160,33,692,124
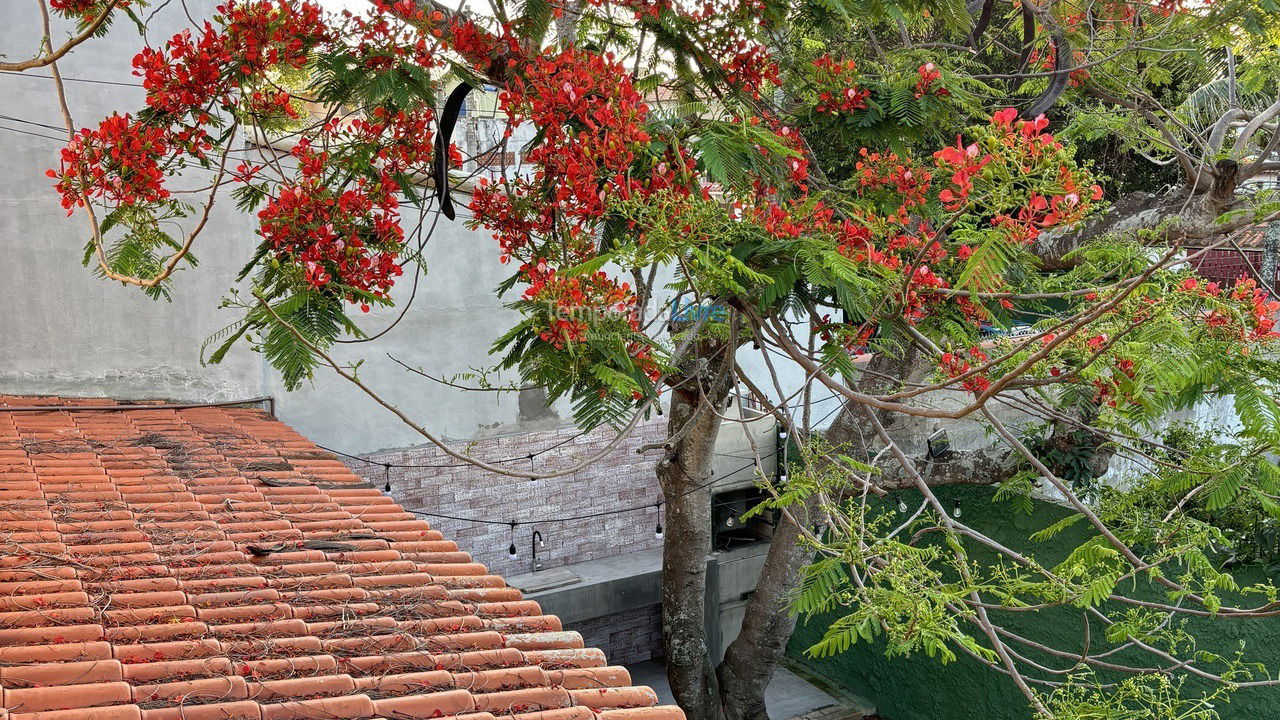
347,416,666,575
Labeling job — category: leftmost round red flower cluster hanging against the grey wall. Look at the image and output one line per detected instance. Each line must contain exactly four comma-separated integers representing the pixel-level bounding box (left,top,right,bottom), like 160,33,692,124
46,115,172,215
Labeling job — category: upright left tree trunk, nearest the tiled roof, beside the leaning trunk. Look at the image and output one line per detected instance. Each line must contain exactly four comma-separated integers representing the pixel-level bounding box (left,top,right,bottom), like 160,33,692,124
657,372,730,720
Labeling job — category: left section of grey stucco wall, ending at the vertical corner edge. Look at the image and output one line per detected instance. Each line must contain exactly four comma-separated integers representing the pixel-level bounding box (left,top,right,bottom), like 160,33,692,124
0,0,262,400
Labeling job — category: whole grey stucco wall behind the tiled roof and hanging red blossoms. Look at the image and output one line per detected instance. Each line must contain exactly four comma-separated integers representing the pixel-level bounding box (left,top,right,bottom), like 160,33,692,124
0,0,563,452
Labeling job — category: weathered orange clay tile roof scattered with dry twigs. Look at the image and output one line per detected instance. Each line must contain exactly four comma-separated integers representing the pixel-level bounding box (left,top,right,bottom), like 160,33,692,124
0,396,684,720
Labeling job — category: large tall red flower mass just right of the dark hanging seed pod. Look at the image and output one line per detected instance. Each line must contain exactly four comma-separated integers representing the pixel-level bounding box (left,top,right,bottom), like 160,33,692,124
471,47,670,377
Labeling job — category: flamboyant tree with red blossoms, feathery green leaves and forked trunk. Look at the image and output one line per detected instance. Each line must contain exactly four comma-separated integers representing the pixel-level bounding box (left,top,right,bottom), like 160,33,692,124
27,0,1280,720
